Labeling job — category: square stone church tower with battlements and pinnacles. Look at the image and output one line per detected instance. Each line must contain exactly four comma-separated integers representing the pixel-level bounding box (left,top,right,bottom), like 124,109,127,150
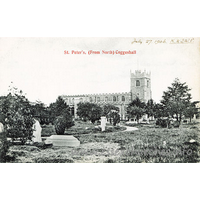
130,70,152,102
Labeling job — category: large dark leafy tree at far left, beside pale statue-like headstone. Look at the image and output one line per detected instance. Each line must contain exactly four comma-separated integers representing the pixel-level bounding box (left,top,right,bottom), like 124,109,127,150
0,88,34,144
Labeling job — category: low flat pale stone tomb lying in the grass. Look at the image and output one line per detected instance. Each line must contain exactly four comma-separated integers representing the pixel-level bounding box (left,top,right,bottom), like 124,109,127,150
45,135,80,147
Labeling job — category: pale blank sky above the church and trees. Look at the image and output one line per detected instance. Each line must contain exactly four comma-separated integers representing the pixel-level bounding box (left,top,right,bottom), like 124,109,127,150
0,37,200,105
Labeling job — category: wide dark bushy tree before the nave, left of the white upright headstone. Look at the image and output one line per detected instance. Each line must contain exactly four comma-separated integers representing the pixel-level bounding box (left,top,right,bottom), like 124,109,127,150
77,102,102,123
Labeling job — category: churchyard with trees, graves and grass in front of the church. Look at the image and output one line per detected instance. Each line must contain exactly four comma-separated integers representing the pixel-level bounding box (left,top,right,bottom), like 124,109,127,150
0,79,200,163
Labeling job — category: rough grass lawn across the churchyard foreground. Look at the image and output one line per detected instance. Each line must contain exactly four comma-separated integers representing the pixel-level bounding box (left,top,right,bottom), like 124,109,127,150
5,121,200,163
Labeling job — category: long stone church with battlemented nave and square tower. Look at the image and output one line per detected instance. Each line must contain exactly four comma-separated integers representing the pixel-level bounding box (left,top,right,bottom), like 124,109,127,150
61,70,152,120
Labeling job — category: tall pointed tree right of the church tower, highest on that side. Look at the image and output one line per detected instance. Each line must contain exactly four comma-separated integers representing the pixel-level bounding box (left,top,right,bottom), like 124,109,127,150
161,79,191,124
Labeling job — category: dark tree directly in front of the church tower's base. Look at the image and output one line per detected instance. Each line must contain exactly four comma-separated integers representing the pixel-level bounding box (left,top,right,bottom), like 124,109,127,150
127,97,146,122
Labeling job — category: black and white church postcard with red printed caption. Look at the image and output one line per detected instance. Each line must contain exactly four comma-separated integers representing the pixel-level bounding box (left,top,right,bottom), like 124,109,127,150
0,37,200,163
